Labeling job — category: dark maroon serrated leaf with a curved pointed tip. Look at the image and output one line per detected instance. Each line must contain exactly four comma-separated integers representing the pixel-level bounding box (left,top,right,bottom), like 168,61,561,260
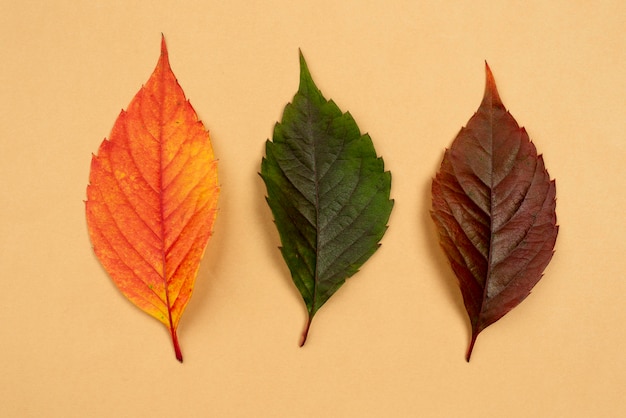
431,65,558,361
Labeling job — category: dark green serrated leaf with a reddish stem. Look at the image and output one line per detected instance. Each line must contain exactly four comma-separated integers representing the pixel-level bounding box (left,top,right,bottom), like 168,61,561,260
261,53,393,346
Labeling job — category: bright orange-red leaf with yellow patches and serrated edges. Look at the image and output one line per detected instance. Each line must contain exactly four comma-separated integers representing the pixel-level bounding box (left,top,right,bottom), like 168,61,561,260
86,39,219,362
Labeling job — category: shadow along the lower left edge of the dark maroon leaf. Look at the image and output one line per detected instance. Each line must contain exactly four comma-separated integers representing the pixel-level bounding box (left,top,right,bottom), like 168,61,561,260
420,158,471,337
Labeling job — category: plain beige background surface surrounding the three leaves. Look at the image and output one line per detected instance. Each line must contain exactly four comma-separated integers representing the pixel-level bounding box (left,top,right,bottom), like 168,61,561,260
0,0,626,417
